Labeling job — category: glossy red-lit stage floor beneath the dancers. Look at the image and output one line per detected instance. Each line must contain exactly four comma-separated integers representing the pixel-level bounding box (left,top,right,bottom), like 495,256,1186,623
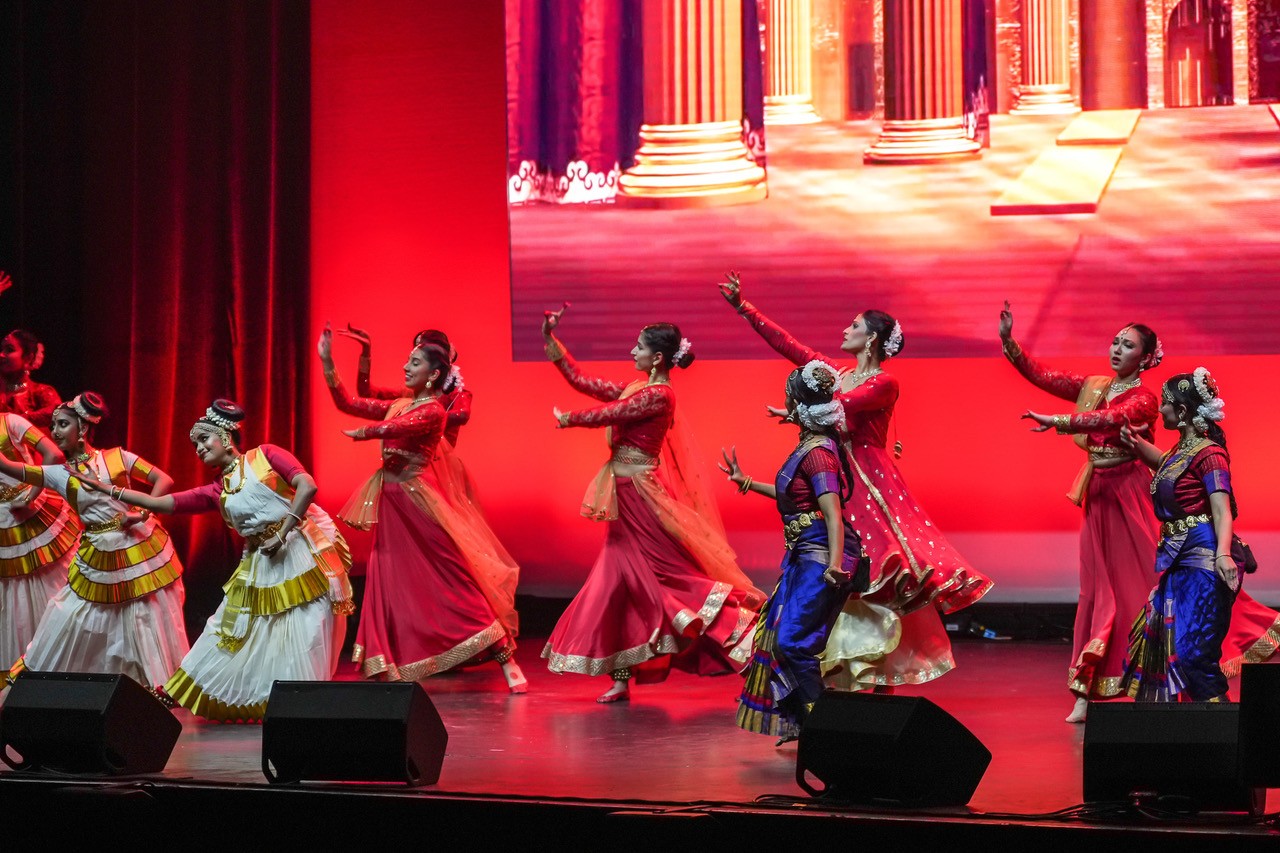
85,638,1280,813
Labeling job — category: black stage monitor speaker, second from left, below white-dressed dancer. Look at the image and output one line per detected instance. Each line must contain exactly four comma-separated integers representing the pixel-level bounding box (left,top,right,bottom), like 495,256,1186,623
262,681,449,785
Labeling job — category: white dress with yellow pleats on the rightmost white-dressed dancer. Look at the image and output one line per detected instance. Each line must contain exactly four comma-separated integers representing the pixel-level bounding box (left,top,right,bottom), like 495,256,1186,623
165,448,352,721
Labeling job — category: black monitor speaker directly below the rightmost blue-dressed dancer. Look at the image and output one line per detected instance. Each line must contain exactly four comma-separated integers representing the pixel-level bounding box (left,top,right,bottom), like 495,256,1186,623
1084,702,1265,813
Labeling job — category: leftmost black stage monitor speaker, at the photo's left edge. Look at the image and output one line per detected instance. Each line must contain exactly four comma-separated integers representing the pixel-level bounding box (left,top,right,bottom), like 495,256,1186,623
0,671,182,775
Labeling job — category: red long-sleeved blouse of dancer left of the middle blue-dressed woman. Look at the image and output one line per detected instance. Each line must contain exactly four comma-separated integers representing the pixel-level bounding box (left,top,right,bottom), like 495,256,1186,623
554,345,676,456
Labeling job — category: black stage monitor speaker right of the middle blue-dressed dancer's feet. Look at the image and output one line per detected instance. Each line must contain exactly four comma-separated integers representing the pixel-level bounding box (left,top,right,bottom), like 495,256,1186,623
796,690,991,806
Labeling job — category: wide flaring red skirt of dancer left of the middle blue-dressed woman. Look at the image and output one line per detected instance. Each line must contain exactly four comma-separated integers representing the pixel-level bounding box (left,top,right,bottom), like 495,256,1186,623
543,478,755,684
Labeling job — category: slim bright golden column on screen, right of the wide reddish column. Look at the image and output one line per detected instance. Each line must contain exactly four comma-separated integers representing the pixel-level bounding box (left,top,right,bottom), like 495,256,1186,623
1011,0,1080,115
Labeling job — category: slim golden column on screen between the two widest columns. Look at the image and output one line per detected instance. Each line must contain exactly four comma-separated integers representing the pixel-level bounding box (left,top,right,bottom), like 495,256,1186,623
764,0,822,126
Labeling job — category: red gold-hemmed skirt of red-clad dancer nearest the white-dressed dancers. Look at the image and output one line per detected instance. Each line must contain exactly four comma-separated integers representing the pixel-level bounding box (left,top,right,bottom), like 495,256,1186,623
353,483,509,681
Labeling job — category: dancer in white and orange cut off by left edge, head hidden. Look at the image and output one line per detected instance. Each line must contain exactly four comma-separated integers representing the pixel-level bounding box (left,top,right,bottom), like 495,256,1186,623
0,414,79,666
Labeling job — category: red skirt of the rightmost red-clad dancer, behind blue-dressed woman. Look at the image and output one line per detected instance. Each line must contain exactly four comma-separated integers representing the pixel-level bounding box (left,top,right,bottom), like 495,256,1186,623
1068,461,1160,699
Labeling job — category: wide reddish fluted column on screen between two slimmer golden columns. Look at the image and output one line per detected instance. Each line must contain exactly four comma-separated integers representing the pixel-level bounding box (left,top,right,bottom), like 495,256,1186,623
864,0,980,163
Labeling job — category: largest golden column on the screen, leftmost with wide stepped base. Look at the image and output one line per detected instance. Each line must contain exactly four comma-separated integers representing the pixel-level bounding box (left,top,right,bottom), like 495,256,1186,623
618,0,767,207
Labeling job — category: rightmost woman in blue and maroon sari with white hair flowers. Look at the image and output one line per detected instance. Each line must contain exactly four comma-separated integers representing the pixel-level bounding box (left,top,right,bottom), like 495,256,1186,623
1121,368,1242,702
